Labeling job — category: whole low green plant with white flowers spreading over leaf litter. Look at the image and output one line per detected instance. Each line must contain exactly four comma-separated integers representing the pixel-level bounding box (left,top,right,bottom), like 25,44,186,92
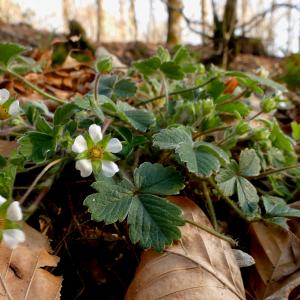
0,44,300,251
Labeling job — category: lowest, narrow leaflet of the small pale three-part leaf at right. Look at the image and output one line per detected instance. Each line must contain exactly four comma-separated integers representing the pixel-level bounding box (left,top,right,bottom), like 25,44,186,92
236,176,259,215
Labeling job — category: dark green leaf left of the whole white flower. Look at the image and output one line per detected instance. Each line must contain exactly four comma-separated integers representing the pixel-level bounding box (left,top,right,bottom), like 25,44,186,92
18,131,54,163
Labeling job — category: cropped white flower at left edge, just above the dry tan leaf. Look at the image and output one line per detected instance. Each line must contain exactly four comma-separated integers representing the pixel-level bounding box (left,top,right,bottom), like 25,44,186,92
0,195,25,249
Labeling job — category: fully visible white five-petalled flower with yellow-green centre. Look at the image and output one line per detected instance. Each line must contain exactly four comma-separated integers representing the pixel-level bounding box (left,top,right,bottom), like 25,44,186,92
72,124,122,177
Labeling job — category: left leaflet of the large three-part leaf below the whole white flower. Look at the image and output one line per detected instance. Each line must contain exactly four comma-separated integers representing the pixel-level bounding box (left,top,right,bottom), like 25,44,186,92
83,181,133,224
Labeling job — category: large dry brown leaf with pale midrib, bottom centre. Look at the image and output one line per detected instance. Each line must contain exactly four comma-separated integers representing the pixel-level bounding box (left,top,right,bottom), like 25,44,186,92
125,197,245,300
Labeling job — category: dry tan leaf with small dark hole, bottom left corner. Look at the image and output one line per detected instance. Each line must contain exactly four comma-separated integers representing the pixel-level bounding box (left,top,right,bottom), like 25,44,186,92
0,224,62,300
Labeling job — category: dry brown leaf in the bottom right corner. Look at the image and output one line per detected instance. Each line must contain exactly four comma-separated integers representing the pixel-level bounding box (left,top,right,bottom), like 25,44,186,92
248,201,300,300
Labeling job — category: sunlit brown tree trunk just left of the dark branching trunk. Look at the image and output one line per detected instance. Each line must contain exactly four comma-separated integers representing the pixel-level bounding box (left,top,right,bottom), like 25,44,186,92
167,0,182,46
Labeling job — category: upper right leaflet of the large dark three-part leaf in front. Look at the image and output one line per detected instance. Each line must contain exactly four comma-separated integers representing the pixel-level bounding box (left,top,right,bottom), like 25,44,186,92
134,162,184,195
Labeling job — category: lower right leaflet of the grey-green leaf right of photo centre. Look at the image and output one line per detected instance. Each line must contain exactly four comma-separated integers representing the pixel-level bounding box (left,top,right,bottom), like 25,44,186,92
175,144,220,177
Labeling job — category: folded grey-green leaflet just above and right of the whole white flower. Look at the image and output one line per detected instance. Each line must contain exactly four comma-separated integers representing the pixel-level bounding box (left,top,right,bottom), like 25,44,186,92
117,101,155,132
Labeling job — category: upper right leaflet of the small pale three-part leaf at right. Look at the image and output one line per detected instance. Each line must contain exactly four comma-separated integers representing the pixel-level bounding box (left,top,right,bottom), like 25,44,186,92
239,149,261,176
